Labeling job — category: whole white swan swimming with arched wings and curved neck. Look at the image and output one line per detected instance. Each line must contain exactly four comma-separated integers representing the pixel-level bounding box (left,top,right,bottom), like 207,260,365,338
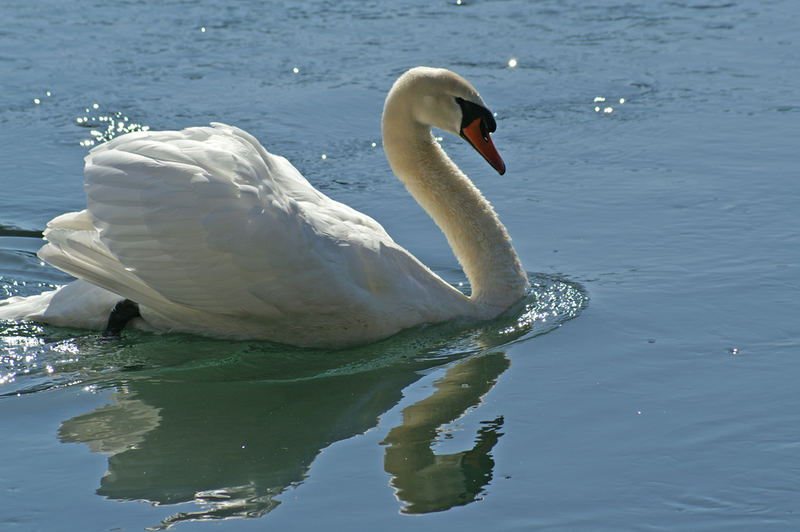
0,67,529,347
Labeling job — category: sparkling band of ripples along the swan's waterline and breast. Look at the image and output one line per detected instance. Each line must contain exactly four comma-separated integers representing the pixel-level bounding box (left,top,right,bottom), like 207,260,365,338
0,275,588,396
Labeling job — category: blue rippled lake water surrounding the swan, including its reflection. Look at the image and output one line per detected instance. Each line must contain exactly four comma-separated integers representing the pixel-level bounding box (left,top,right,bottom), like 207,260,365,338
0,0,800,532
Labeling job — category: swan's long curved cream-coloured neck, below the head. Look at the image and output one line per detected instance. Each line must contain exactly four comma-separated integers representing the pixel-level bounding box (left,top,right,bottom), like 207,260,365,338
383,116,529,317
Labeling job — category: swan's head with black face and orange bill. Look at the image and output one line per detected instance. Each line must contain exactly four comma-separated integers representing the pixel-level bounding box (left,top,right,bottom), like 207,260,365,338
387,67,506,175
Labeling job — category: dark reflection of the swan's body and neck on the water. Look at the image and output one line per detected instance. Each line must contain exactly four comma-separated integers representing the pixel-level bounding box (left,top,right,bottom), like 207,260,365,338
59,344,509,526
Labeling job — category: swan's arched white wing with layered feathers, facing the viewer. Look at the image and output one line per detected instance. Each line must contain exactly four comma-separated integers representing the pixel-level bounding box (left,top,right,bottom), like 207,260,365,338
54,124,438,319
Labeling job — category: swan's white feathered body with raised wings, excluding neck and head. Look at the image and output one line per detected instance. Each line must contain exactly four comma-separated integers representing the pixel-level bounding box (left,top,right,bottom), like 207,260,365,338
40,124,466,345
